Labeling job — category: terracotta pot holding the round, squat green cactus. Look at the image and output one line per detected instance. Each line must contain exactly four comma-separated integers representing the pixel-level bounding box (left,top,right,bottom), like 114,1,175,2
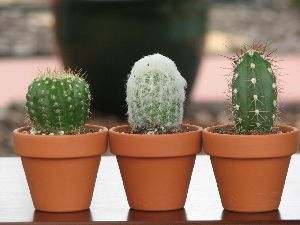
13,125,108,212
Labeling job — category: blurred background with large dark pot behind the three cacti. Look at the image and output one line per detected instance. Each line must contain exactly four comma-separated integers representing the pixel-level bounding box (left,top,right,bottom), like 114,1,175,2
0,0,300,156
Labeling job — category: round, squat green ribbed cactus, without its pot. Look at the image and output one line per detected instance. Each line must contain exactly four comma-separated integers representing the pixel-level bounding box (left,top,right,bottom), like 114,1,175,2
26,70,91,134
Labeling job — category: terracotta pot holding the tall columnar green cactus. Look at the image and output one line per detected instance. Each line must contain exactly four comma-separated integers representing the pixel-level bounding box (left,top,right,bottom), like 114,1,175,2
203,126,298,212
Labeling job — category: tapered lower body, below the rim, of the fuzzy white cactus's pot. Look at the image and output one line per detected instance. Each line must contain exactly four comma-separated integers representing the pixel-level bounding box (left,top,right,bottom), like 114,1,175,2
117,155,196,211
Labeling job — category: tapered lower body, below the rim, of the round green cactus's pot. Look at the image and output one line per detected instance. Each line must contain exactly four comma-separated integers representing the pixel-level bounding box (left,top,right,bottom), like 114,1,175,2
22,156,100,213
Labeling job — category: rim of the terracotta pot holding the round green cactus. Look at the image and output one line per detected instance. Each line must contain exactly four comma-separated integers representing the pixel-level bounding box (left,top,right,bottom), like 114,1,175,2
13,124,108,158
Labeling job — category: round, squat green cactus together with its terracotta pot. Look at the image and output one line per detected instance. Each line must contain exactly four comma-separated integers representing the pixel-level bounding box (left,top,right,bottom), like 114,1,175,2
13,70,107,212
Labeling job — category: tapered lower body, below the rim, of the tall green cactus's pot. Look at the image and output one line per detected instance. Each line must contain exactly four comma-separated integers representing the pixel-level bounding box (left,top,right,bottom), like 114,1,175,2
211,157,291,213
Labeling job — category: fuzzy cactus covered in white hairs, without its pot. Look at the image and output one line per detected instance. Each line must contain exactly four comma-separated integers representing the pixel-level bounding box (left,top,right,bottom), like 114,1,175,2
126,54,186,134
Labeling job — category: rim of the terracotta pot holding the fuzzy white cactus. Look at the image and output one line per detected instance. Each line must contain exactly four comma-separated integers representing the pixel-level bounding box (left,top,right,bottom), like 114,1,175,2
109,124,202,158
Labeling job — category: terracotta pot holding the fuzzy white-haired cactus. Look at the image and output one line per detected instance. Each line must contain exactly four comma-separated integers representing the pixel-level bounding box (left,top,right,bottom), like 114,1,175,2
109,125,201,211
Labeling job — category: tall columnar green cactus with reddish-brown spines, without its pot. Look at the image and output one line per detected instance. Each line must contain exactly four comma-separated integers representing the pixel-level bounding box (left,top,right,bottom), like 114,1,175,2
231,44,277,134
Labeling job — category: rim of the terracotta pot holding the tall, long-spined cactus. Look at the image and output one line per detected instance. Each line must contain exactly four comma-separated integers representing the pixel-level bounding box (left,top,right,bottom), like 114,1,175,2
203,124,298,159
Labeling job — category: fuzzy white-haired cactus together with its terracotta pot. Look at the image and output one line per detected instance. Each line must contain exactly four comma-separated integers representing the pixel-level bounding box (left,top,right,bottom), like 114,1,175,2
109,54,201,211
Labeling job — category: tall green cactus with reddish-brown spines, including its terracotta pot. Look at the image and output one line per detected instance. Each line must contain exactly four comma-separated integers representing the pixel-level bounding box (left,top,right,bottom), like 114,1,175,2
203,44,298,212
